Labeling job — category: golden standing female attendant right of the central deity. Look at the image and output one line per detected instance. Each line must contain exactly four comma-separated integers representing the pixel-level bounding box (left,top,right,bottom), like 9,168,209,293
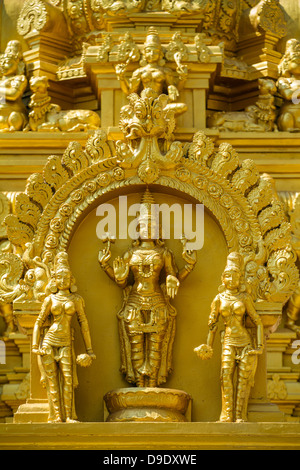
195,253,263,422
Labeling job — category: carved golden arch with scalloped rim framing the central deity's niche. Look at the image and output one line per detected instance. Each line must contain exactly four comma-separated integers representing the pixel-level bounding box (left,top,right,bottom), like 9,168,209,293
5,130,298,303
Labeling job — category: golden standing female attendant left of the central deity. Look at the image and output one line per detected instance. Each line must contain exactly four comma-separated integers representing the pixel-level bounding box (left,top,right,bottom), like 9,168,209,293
32,252,95,422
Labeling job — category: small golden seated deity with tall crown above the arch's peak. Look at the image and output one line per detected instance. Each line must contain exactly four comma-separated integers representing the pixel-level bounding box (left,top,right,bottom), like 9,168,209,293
116,27,187,115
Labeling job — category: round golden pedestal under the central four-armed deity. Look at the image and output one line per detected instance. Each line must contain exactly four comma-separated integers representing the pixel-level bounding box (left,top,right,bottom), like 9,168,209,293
104,387,191,422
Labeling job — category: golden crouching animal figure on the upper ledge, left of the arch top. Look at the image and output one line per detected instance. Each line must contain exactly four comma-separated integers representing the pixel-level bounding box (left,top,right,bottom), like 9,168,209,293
24,77,100,132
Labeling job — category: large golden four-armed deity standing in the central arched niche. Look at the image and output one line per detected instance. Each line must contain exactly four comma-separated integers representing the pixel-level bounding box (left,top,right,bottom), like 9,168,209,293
99,191,196,387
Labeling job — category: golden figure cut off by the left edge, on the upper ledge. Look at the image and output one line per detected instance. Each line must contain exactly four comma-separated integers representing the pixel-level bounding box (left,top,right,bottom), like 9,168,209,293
0,40,27,132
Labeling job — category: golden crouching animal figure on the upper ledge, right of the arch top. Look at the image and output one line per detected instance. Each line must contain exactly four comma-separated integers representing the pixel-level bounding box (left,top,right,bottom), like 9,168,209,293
207,79,277,132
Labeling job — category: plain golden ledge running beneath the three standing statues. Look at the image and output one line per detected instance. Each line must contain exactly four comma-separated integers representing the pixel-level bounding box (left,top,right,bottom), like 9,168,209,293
0,422,300,452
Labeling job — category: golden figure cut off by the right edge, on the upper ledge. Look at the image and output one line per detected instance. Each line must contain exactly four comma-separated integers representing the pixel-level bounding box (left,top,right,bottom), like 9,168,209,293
277,39,300,132
